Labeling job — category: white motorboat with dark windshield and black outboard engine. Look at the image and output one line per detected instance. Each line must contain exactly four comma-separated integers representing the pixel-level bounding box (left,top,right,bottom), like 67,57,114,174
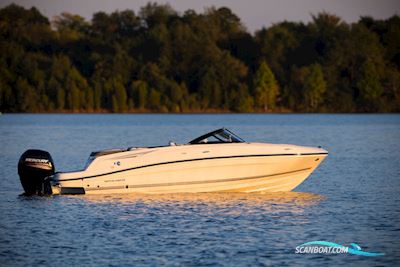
18,128,328,195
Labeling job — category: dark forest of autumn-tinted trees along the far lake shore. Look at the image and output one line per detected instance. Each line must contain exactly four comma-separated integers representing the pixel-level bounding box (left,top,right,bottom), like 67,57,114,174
0,3,400,112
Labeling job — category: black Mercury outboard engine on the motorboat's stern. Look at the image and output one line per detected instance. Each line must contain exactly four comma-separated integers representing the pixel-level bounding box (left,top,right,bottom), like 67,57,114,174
18,149,54,196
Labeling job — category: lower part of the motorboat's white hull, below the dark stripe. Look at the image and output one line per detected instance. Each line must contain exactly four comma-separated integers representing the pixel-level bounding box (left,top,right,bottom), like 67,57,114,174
53,153,327,194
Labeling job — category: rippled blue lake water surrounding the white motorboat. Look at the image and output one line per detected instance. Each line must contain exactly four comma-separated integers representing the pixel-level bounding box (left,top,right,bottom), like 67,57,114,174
0,114,400,266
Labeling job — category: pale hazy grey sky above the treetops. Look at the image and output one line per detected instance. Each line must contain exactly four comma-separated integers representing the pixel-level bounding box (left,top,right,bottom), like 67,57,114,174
0,0,400,32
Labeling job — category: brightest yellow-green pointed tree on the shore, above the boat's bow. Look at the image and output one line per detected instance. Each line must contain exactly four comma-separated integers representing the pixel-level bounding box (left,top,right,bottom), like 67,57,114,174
253,61,279,111
